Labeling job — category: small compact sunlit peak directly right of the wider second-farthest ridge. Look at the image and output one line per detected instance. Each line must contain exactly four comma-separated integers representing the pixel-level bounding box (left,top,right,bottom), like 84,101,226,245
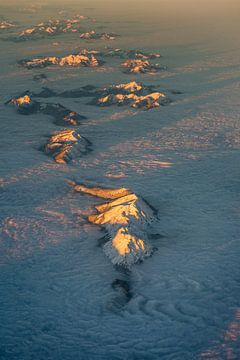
122,59,162,74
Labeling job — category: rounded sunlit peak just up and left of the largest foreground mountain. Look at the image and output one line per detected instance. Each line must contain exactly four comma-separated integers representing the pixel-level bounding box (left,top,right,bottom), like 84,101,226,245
45,129,90,164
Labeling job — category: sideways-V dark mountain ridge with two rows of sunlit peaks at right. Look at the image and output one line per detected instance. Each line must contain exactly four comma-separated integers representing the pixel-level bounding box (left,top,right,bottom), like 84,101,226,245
13,81,171,112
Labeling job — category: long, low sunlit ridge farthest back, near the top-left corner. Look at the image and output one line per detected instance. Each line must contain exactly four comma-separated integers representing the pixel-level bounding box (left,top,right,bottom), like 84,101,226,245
12,15,86,41
